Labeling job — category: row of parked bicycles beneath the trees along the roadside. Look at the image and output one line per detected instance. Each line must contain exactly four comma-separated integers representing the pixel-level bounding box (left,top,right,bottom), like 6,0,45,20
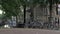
17,21,59,29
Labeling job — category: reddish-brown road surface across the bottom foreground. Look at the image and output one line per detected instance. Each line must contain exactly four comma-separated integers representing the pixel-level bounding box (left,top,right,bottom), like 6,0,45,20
0,28,60,34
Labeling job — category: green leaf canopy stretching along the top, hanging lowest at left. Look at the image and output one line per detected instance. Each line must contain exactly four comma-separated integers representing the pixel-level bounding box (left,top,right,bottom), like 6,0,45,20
0,0,59,17
